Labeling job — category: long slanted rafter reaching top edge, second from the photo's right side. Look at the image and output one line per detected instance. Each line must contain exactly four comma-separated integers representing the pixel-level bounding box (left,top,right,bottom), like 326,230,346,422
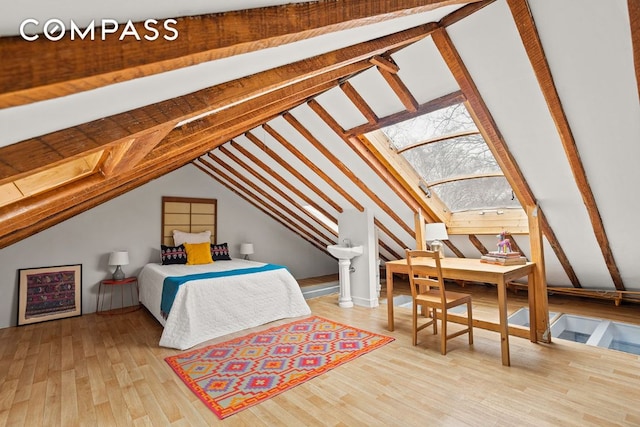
507,0,625,291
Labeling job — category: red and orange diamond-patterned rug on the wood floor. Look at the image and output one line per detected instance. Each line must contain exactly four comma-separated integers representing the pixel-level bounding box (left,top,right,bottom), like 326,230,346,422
165,316,394,419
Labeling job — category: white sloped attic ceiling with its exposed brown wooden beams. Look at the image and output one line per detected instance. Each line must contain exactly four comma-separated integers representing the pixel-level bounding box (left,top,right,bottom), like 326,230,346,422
0,0,640,291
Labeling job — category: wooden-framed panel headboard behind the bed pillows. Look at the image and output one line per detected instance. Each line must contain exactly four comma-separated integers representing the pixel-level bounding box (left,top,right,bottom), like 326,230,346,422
162,197,218,246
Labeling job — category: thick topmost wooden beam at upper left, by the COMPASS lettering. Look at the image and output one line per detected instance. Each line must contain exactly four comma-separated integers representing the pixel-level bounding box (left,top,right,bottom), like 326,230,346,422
0,0,473,108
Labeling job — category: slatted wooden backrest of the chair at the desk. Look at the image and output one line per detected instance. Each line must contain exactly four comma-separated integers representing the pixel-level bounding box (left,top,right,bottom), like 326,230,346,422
406,249,446,302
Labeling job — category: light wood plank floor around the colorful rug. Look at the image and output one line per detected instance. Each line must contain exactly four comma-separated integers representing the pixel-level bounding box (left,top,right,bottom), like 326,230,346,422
0,280,640,427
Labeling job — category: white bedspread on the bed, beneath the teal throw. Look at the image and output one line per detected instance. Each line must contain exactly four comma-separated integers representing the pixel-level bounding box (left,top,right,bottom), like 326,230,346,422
138,259,311,350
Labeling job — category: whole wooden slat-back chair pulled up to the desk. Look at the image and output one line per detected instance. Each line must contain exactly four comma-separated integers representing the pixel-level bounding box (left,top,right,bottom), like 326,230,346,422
406,249,473,354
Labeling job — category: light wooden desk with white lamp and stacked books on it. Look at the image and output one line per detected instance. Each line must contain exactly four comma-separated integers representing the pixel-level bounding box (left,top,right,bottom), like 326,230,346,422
386,258,549,366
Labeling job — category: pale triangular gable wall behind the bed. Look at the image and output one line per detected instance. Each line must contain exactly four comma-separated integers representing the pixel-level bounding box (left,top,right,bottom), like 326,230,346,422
0,166,338,328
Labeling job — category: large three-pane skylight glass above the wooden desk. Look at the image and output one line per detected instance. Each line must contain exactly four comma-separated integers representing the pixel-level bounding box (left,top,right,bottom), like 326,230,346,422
382,104,521,212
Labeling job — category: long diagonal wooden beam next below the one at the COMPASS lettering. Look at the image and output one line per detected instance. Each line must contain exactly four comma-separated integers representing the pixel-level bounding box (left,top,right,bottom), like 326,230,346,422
0,20,434,184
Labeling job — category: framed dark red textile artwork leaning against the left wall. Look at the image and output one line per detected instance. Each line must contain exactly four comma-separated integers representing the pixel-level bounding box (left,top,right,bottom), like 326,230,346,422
18,264,82,325
